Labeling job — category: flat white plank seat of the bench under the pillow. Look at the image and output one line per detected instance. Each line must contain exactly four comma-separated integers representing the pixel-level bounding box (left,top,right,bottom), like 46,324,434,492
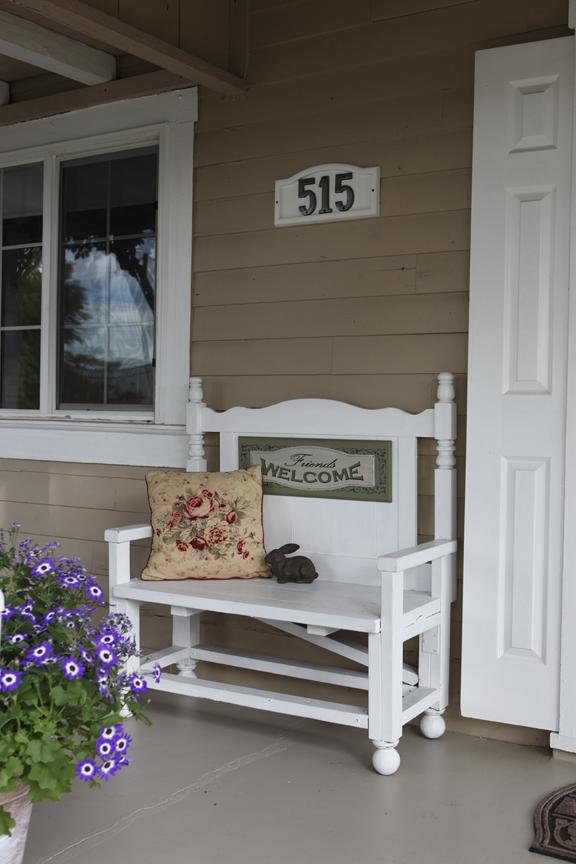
113,579,440,633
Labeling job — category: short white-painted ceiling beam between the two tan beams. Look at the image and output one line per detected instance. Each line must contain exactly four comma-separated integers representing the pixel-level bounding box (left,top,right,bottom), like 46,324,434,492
0,11,116,84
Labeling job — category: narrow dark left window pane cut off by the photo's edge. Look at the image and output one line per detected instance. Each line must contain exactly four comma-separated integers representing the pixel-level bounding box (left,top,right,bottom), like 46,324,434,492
0,163,43,409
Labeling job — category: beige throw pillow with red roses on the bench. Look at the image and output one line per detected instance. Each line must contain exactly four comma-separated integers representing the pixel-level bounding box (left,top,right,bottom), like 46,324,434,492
142,466,270,579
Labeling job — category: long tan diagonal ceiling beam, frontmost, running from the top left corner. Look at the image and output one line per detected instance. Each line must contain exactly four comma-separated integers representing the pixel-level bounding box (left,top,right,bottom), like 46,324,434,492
2,0,247,96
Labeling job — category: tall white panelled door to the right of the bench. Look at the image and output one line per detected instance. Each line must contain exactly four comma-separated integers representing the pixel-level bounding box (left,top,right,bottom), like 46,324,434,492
462,37,574,729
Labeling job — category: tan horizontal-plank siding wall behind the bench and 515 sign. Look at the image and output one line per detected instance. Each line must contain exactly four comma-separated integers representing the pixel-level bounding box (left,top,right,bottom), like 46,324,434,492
0,0,568,742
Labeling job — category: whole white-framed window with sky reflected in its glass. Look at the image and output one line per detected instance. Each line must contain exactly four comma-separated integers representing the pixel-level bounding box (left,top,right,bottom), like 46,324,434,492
0,88,196,465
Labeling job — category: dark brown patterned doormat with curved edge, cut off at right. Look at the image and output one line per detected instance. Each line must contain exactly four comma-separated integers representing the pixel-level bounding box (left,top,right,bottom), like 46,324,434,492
530,783,576,861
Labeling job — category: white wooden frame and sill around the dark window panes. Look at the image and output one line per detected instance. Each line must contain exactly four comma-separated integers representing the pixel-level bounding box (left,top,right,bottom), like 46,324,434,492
0,88,198,466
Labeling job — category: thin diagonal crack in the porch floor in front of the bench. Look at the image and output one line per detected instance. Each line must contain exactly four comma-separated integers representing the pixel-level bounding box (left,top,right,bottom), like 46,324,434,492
33,735,290,864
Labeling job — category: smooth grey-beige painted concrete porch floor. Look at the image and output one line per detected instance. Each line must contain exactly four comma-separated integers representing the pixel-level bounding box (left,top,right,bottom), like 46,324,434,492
20,699,576,864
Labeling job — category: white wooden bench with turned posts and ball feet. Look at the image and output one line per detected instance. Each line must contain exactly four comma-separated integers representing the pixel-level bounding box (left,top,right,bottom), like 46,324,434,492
105,373,456,774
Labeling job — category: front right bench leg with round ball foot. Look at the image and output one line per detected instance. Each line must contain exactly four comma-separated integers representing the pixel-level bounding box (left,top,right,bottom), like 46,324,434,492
368,573,404,775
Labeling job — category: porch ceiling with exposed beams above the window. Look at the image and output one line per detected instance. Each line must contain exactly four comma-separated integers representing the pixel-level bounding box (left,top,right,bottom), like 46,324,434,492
0,0,247,125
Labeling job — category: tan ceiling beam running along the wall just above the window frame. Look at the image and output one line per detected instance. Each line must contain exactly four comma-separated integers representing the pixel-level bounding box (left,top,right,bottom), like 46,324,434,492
0,71,190,127
